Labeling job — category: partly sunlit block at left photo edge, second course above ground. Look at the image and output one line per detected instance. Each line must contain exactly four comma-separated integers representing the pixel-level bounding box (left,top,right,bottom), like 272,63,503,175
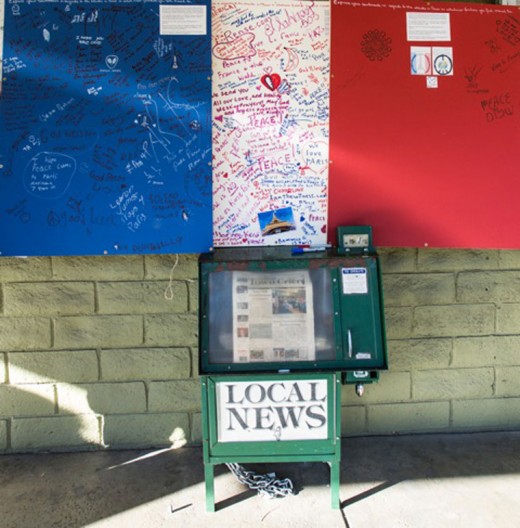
0,384,56,418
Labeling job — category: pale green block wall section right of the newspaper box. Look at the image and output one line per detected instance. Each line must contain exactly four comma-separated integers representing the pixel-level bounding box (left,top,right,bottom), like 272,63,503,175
342,249,520,435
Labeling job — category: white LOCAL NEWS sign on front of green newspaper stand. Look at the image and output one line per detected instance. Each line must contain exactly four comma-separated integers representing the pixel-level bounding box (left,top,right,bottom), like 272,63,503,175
215,378,329,442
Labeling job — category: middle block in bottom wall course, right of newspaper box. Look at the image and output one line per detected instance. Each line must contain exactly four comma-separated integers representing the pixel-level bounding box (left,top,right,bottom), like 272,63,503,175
368,402,450,436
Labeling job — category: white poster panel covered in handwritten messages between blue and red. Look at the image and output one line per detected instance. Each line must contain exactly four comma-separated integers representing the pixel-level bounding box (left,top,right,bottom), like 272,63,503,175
212,0,330,246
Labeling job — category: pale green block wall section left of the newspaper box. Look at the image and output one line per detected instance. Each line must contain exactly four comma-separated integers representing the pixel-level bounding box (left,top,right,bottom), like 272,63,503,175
0,255,200,452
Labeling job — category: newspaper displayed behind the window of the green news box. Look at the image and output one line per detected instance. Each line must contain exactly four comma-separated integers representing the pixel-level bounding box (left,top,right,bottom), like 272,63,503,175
233,270,316,363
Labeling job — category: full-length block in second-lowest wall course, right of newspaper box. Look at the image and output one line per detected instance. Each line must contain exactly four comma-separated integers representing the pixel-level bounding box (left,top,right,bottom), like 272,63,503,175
412,368,494,400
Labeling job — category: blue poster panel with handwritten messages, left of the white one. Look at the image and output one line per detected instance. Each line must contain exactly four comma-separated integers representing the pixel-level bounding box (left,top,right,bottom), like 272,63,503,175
0,0,212,255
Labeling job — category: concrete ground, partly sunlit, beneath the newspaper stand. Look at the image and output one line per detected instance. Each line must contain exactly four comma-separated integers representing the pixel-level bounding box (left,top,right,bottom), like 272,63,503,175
0,432,520,528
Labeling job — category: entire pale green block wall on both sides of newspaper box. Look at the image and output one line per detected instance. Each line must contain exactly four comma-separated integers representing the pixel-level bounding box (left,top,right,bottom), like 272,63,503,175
0,249,520,452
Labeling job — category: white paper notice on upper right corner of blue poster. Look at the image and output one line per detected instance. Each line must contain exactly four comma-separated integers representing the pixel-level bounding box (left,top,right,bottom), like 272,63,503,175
159,5,207,35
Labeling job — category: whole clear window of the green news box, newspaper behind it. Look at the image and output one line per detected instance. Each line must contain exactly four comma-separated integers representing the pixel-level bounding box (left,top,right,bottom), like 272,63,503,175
208,268,335,364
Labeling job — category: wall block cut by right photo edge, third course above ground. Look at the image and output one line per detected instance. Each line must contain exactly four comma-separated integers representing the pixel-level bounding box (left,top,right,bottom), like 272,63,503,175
452,335,520,367
